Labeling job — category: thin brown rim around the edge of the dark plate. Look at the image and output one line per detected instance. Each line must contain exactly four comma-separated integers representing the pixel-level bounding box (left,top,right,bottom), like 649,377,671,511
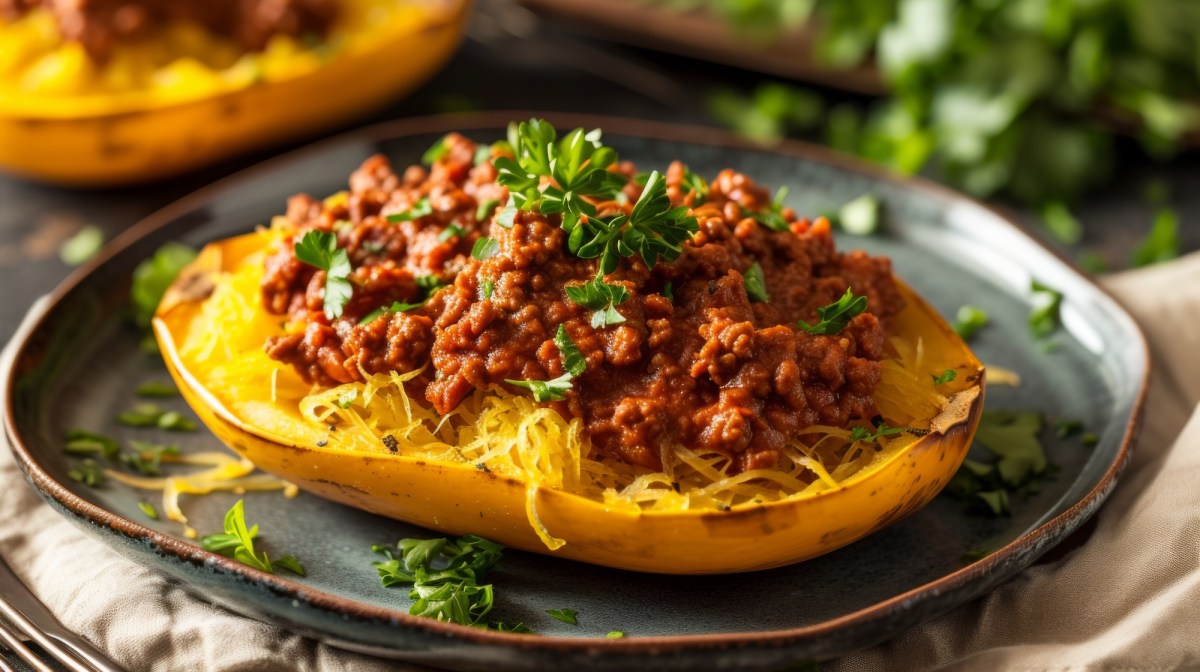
0,110,1152,654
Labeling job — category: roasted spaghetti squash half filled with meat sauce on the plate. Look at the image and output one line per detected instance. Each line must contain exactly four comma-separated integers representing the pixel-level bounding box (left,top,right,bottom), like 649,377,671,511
154,120,984,574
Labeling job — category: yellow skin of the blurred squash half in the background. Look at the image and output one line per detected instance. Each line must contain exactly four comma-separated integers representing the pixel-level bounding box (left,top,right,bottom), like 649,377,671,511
0,0,470,187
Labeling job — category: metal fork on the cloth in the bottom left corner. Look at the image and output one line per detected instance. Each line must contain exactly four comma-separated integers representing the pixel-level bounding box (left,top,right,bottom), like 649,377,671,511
0,558,125,672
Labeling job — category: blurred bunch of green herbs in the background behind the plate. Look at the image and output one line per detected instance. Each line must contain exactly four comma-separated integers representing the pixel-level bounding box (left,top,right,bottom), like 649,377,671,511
701,0,1200,254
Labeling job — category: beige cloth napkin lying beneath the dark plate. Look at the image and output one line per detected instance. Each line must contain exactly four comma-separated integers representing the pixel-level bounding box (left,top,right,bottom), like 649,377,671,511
0,253,1200,672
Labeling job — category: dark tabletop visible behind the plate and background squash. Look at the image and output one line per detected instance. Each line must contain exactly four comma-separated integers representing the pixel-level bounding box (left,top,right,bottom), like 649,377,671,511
0,0,1200,342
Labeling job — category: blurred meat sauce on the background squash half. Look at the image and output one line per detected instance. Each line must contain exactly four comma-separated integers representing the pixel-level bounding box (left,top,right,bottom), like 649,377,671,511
0,0,337,60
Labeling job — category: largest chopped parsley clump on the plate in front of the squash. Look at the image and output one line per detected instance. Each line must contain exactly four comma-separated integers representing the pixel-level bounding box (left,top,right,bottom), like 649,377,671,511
372,535,506,632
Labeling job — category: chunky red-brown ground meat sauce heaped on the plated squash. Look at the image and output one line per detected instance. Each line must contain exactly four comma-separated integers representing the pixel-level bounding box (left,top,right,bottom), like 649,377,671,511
262,136,904,470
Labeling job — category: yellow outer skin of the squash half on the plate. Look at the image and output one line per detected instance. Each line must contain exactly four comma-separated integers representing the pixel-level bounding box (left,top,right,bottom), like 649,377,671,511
154,234,984,574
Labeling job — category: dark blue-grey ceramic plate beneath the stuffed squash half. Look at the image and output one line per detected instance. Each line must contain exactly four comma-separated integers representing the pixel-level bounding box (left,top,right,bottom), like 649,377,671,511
5,113,1148,670
